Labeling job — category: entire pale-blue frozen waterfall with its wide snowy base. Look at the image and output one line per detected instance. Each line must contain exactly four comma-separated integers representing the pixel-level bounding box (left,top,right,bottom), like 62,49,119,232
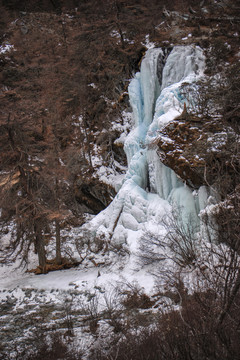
80,45,208,250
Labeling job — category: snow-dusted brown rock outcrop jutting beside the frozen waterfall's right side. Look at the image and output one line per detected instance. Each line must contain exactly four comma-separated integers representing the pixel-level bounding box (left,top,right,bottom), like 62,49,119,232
157,112,238,193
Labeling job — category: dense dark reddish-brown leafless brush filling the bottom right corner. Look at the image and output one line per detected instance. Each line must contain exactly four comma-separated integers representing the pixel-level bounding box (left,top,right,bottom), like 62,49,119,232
91,284,240,360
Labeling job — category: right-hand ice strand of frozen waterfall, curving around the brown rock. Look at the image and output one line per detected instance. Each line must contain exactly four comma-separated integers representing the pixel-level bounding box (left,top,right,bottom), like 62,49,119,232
146,46,204,222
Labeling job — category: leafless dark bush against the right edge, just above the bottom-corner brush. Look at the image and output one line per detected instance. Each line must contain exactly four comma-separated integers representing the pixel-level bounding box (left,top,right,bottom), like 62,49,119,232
198,198,240,324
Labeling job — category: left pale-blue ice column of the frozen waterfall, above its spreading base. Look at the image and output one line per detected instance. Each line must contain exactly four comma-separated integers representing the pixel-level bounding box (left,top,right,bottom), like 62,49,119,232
124,49,164,189
